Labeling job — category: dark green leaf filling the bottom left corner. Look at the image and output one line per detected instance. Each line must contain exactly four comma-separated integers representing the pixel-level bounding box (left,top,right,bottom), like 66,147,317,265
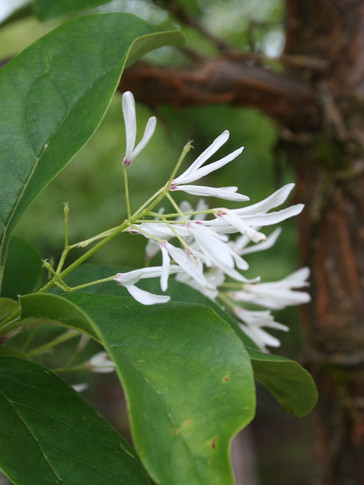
0,358,150,485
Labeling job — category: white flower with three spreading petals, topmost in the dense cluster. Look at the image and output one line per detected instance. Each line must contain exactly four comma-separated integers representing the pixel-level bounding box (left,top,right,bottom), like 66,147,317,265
170,130,249,201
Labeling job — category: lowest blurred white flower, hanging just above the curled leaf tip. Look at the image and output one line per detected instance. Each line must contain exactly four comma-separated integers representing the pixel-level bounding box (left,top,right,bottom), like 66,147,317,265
234,306,289,351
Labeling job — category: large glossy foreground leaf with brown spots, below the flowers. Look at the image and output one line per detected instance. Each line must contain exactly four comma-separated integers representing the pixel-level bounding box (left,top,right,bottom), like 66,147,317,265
21,293,255,485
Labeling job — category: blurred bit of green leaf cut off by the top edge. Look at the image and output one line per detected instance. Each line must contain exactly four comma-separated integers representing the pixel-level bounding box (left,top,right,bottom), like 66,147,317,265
34,0,110,20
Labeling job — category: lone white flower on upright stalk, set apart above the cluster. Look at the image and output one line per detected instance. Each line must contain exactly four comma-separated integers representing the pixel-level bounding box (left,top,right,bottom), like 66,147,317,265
122,91,157,167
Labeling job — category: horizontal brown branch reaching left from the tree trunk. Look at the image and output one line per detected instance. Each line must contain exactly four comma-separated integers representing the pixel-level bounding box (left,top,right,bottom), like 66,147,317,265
119,55,320,132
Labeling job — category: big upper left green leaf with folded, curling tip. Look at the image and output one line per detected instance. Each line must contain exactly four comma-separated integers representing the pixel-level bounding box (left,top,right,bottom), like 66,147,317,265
0,13,182,272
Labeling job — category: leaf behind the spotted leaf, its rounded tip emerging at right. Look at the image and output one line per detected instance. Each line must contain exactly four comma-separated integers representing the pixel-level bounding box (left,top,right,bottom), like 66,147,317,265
55,264,317,416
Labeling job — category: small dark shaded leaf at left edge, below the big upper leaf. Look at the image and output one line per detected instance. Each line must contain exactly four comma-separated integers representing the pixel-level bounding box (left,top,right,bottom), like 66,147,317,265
1,236,42,300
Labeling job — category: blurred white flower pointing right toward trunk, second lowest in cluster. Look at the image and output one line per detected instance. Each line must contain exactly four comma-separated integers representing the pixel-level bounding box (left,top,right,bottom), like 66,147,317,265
229,268,311,310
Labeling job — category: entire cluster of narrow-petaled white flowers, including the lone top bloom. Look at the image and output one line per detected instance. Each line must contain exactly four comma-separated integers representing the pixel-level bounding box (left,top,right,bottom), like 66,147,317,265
114,92,309,350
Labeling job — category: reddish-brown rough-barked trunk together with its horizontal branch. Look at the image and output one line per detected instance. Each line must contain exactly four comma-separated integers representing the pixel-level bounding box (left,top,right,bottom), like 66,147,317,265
120,0,364,485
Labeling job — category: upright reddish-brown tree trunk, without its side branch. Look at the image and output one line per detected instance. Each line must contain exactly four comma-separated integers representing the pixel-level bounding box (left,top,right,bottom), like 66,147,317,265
286,0,364,485
